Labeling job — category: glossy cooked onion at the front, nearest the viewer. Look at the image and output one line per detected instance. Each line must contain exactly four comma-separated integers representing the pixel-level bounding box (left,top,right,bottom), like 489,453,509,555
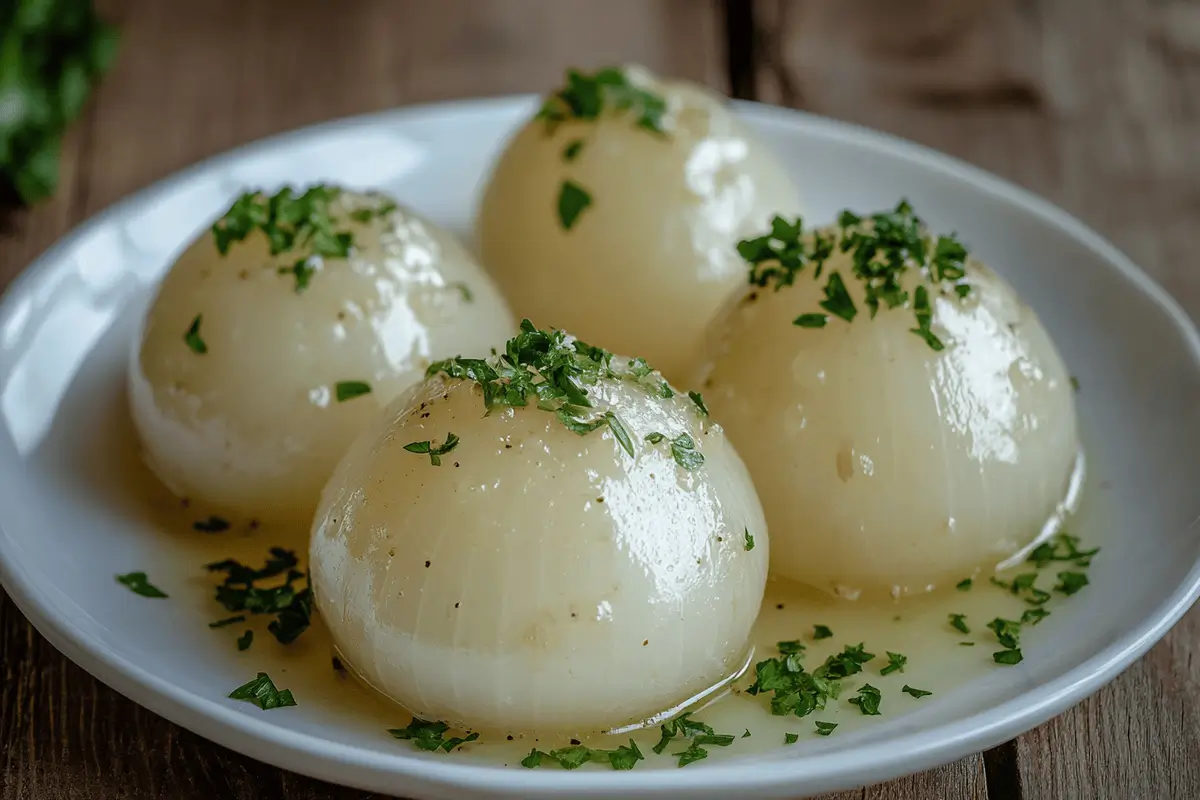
310,378,768,733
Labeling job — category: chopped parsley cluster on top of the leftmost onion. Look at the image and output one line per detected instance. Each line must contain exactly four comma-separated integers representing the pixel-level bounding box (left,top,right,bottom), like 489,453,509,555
212,185,384,293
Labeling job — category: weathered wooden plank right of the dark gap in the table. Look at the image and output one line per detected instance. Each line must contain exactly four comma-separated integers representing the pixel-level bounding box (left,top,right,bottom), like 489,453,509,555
755,0,1200,800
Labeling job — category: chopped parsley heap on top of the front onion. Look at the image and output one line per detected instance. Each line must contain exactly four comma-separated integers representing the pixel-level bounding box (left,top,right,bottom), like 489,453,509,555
425,319,648,457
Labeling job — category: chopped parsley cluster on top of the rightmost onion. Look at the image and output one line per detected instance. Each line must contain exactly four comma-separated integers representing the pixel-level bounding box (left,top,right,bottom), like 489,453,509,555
738,201,971,351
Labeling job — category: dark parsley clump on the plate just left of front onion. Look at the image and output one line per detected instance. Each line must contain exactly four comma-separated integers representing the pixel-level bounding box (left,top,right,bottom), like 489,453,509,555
205,547,312,644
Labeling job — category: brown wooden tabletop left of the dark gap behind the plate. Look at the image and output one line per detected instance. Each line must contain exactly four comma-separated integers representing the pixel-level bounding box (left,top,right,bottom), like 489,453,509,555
0,0,725,800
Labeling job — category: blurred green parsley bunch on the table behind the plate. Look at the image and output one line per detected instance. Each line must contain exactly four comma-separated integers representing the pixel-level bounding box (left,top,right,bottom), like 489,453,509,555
0,0,116,205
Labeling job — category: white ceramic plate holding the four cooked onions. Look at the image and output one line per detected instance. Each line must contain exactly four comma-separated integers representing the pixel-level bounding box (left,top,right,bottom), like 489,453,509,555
0,98,1200,800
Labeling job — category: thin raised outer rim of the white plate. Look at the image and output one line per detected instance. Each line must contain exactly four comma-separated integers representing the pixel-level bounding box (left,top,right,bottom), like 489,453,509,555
0,94,1200,798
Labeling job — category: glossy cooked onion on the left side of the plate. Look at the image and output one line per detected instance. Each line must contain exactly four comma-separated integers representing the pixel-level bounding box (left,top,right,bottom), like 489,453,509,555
130,192,515,531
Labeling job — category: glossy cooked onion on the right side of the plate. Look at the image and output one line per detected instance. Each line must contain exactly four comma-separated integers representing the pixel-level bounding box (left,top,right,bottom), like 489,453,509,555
696,226,1080,597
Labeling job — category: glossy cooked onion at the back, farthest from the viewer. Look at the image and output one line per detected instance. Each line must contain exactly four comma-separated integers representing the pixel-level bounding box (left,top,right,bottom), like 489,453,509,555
478,68,798,381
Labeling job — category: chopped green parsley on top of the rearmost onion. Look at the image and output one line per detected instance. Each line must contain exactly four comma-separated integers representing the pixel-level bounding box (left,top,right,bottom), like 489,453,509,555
534,67,667,230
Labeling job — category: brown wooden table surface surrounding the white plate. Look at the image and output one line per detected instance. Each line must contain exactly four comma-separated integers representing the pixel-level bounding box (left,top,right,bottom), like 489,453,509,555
0,0,1200,800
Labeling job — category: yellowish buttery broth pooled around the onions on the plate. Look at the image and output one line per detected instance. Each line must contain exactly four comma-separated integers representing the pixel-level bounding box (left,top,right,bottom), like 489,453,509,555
129,438,1097,769
